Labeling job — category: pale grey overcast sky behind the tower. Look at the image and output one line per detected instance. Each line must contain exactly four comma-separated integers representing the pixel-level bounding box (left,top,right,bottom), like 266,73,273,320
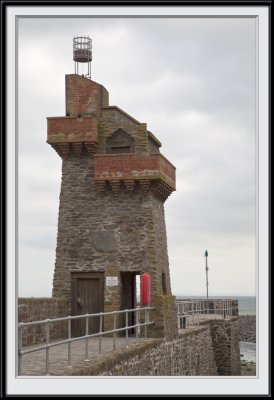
18,18,255,297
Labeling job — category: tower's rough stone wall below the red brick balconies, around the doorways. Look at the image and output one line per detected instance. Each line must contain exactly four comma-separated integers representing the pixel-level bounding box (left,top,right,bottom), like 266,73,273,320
53,155,171,304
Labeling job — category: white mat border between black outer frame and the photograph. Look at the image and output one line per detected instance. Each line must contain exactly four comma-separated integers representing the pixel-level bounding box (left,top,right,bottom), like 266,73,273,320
6,6,269,395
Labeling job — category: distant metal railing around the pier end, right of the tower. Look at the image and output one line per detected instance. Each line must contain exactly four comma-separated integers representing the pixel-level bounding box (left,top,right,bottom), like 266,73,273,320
176,300,234,329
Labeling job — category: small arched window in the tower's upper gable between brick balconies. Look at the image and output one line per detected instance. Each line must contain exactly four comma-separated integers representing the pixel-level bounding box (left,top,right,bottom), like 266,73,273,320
106,129,135,154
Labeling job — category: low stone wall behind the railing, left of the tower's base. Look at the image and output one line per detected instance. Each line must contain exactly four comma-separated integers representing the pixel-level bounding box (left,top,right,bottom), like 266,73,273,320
18,297,70,346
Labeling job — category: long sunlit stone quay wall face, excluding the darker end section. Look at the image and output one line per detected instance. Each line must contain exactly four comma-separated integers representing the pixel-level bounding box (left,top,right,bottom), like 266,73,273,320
58,324,217,376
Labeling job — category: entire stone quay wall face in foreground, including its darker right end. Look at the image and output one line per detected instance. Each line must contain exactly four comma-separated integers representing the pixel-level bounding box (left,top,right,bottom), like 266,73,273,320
56,317,241,376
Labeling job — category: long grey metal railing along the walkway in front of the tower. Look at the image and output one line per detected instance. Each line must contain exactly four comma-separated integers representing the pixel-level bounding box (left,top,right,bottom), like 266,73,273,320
18,307,154,375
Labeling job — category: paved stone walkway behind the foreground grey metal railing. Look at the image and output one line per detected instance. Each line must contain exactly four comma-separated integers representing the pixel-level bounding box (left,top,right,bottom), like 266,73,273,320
20,337,142,376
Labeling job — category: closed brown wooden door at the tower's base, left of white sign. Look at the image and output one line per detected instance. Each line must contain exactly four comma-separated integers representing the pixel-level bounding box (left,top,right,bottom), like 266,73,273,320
71,272,104,336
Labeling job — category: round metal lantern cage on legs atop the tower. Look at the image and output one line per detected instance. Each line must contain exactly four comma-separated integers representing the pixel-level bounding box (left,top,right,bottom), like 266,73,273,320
73,36,92,79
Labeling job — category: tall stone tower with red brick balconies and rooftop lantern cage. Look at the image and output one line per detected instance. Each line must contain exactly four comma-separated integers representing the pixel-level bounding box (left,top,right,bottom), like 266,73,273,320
47,37,175,336
